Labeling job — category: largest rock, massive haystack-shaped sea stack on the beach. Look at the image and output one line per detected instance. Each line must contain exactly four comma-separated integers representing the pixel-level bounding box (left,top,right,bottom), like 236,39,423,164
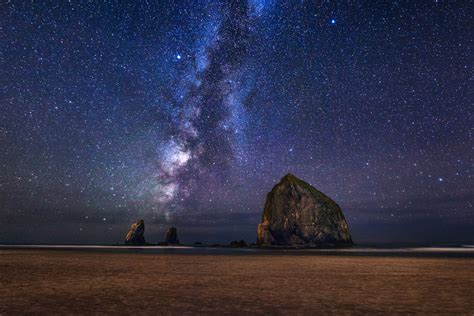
257,174,352,247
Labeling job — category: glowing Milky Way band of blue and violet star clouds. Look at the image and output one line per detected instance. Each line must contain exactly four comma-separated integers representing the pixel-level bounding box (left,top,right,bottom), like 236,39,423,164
147,3,262,214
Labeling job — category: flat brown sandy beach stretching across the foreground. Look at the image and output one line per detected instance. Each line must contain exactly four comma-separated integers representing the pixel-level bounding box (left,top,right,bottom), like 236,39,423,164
0,249,474,315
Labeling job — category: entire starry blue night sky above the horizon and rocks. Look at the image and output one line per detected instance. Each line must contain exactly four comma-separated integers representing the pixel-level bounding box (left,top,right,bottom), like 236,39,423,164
0,0,474,243
